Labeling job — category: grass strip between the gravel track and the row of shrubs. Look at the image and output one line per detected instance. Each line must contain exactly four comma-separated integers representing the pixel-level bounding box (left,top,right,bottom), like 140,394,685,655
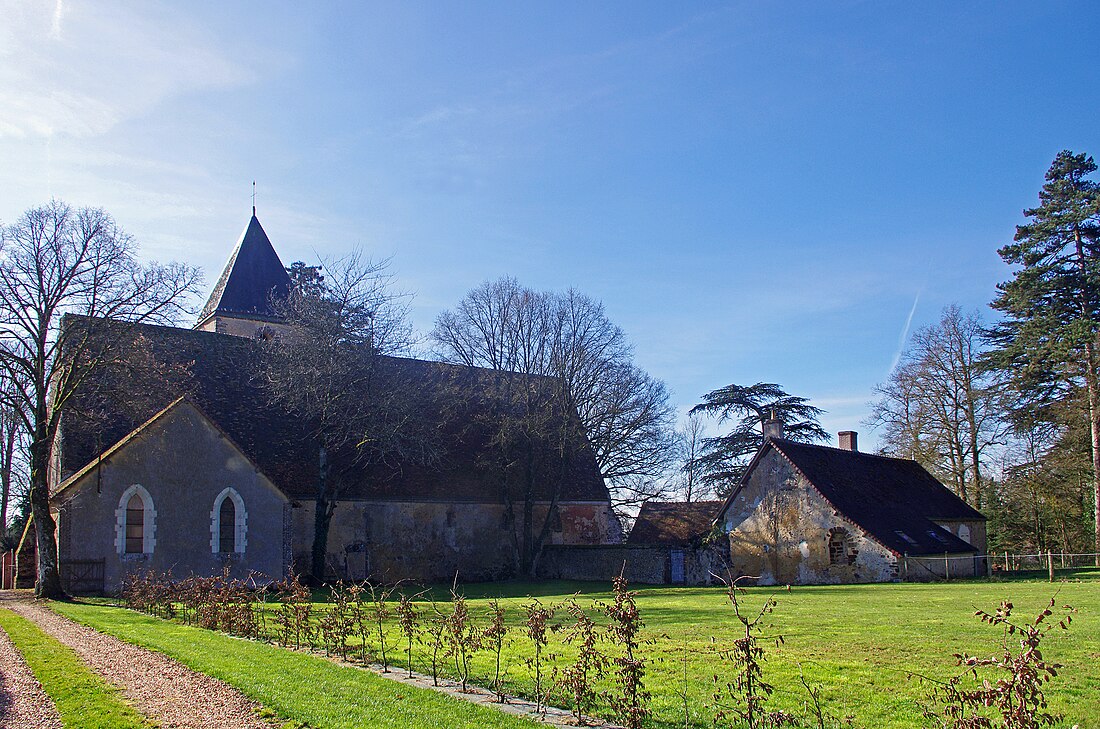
51,603,541,729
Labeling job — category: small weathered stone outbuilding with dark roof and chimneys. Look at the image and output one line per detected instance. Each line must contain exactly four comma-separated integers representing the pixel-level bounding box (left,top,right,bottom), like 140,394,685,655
715,431,987,585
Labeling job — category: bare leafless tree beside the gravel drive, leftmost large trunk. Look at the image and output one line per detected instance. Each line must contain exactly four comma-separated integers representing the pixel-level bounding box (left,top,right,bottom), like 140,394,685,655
0,200,200,597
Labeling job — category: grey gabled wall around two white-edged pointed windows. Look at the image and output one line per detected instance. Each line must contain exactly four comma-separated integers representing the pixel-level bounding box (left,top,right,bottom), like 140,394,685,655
54,402,286,592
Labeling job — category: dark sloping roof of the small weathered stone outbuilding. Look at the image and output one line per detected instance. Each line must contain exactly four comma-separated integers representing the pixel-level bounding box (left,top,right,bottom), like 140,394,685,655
727,439,986,555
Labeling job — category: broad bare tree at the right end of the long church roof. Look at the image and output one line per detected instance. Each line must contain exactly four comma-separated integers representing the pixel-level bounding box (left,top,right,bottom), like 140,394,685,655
432,278,675,572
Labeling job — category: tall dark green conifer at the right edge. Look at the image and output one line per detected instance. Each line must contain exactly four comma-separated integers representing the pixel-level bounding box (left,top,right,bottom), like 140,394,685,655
992,150,1100,566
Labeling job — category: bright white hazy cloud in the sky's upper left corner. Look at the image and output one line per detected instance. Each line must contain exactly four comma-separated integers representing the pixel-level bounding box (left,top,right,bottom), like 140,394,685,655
0,1,251,139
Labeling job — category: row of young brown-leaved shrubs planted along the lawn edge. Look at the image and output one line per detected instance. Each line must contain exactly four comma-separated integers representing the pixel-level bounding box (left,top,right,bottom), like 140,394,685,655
122,571,1074,729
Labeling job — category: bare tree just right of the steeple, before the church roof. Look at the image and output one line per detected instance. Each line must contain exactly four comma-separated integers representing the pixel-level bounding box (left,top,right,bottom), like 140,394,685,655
263,252,431,582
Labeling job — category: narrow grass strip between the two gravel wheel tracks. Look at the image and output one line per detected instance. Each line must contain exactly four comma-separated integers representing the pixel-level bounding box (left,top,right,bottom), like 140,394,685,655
0,608,152,729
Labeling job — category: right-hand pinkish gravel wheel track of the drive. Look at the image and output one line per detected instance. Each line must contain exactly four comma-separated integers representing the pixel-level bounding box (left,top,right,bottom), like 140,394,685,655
0,598,277,729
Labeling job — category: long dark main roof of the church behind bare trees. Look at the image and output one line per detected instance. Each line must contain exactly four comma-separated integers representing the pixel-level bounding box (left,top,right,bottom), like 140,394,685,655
61,317,608,502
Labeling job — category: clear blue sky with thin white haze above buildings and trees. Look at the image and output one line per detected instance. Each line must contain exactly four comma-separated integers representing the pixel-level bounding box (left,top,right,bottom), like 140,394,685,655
0,1,1100,445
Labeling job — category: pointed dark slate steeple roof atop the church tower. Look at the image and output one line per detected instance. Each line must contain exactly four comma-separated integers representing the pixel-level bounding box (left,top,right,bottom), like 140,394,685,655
198,211,290,325
